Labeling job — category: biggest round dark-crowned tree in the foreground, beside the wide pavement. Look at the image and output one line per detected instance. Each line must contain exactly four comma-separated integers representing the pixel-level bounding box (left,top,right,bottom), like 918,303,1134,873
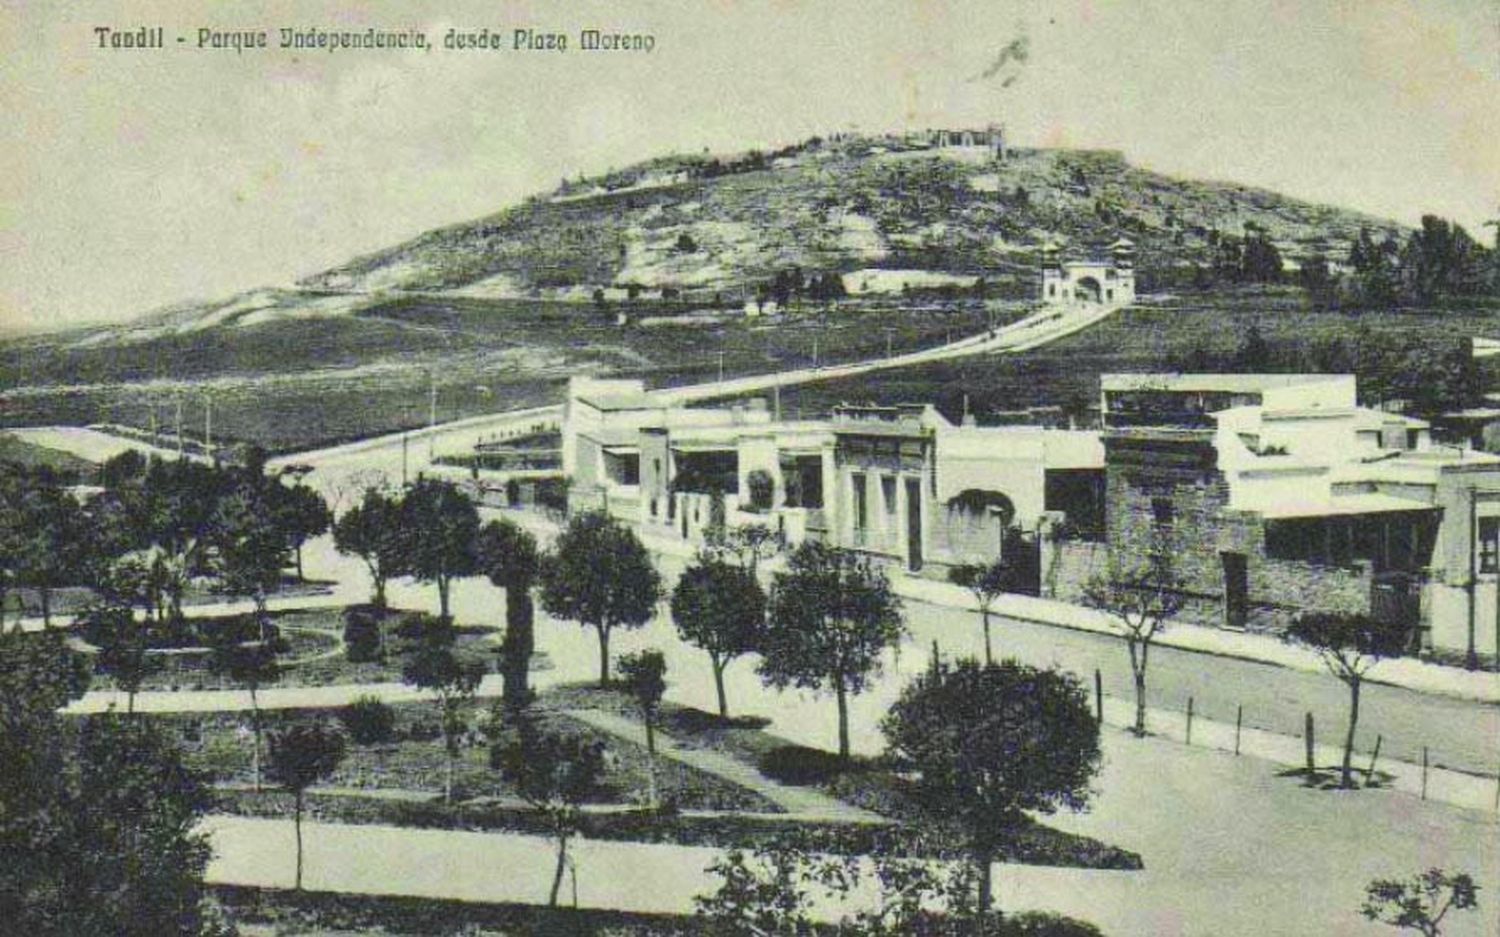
881,660,1100,913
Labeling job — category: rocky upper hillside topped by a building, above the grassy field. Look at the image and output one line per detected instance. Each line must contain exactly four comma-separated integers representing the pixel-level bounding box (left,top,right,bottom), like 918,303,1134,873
305,138,1401,298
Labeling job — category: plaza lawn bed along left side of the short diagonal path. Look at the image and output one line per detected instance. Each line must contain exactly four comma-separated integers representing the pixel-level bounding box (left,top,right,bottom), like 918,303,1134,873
152,702,780,813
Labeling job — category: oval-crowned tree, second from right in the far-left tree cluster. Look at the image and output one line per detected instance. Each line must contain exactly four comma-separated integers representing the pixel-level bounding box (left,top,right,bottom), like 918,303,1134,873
213,483,290,642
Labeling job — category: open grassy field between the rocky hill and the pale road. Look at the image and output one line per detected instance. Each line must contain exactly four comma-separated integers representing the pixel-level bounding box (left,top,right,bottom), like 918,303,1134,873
0,297,1016,451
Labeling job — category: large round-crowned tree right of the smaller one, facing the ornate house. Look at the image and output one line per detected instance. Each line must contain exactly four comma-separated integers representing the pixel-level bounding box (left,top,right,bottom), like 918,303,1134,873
759,541,906,760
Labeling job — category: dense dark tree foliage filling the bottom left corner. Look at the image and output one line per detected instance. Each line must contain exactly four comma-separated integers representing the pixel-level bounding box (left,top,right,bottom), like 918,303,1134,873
0,631,225,937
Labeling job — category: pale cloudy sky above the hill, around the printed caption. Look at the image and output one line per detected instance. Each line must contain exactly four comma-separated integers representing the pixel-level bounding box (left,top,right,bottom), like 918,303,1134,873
0,0,1500,331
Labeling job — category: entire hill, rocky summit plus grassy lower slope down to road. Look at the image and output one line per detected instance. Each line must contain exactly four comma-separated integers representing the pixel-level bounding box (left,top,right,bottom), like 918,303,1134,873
0,135,1440,450
